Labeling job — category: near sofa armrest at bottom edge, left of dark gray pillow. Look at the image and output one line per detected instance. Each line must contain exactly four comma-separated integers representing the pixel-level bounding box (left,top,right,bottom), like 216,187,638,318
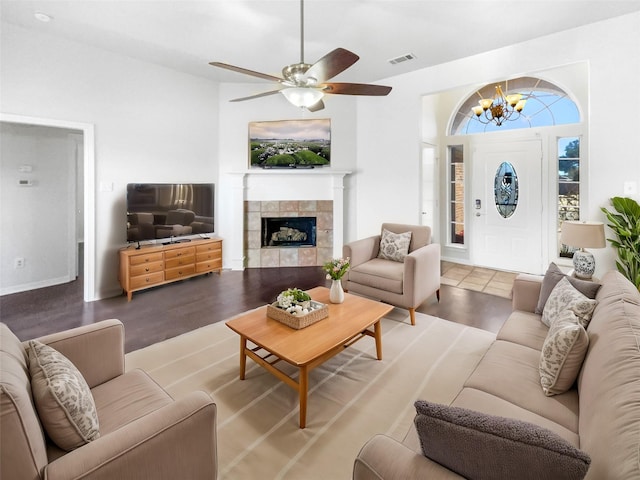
353,435,464,480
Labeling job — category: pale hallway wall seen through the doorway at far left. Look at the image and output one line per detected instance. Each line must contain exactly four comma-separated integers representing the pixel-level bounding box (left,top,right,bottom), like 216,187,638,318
0,123,76,295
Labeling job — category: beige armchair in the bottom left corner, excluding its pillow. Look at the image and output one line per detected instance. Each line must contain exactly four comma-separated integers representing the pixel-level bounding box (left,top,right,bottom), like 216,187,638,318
0,320,217,480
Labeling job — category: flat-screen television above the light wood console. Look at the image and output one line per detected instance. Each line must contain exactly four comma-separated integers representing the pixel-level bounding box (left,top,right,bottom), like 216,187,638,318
127,183,215,242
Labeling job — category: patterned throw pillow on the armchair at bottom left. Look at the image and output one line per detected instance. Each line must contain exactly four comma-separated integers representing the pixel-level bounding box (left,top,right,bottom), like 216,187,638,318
28,340,100,451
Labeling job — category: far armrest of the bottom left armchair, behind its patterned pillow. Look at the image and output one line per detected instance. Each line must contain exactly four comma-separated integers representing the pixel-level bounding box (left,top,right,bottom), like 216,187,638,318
36,319,125,388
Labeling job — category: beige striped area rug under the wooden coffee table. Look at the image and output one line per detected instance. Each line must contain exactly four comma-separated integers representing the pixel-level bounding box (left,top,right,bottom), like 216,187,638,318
126,309,495,480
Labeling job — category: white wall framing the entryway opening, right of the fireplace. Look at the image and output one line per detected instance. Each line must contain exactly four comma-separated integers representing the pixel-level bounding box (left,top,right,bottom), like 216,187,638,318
352,13,640,273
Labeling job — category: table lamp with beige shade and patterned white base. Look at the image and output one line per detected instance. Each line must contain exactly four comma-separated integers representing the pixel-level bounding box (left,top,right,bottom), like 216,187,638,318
560,220,606,280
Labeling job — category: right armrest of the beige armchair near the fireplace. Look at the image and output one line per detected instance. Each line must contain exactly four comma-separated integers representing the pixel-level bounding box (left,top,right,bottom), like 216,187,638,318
403,243,440,305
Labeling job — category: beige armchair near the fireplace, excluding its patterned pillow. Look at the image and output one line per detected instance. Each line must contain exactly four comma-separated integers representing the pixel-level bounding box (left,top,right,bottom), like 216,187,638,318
342,223,440,325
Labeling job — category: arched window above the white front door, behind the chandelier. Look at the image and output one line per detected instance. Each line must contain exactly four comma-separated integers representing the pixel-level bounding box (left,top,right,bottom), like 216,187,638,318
449,77,580,135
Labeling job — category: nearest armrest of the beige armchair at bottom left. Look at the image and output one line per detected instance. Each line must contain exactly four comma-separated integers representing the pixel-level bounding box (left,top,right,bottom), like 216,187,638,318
45,392,218,480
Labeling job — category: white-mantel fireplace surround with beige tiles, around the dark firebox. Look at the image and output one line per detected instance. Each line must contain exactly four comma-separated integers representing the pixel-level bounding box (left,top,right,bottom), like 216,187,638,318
226,168,351,270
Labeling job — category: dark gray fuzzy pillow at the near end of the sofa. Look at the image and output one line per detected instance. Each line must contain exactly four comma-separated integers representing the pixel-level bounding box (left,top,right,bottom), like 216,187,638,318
415,400,591,480
